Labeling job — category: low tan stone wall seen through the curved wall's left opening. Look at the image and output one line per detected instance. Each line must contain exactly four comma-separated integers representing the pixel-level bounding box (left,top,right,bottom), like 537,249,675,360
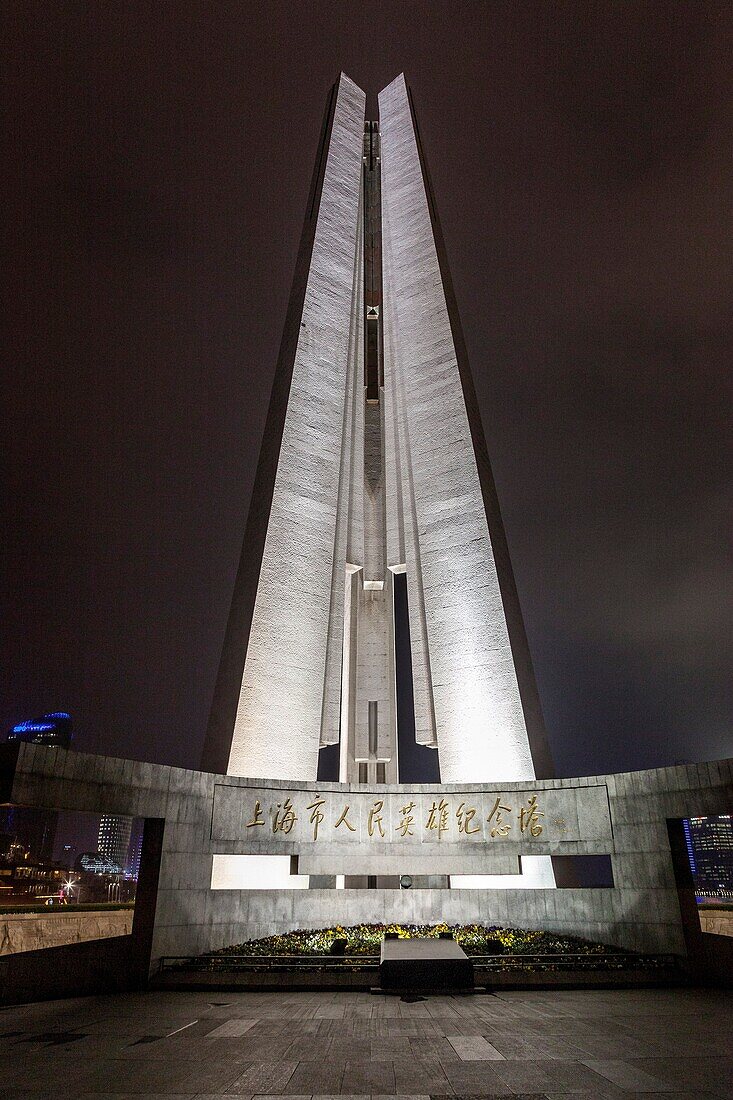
0,909,133,955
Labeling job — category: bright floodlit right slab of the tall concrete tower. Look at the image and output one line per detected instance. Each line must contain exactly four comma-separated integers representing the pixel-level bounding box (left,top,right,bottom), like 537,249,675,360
380,77,551,800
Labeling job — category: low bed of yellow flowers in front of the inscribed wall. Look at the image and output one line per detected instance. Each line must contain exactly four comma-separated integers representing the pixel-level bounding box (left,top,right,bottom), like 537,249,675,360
215,924,623,955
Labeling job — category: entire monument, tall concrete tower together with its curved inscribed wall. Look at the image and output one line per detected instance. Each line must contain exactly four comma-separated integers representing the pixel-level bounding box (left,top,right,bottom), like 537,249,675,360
0,76,733,999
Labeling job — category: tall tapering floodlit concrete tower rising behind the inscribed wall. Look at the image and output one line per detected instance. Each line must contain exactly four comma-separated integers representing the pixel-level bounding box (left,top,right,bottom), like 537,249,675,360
204,75,553,873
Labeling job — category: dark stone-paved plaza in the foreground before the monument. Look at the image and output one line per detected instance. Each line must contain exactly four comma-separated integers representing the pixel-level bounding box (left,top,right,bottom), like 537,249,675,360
0,990,733,1100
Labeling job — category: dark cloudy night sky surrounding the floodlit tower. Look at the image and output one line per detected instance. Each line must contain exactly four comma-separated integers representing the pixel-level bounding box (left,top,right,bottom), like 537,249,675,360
0,0,733,774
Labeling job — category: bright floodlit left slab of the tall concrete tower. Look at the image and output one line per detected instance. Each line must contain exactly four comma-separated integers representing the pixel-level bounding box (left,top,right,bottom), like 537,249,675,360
220,75,364,779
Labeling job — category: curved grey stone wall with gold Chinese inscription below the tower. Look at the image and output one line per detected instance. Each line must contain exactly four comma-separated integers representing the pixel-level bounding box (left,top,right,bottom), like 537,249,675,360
1,745,733,968
